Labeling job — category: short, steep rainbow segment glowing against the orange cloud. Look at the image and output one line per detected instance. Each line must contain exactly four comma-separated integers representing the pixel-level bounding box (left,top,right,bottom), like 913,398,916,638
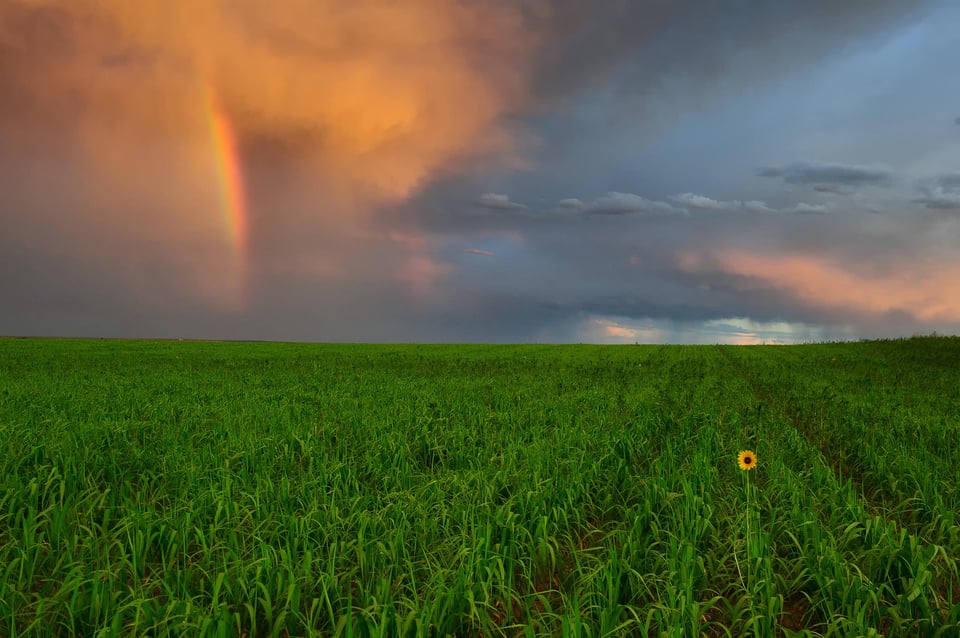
205,85,249,302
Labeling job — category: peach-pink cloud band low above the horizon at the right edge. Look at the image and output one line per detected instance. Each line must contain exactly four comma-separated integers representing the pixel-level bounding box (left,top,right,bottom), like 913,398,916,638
679,250,960,323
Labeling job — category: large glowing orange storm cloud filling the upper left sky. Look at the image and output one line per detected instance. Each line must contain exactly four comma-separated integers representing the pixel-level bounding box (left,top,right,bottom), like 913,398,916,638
3,0,532,196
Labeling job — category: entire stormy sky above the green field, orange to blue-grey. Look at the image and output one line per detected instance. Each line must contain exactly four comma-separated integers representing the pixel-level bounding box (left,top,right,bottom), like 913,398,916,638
0,0,960,344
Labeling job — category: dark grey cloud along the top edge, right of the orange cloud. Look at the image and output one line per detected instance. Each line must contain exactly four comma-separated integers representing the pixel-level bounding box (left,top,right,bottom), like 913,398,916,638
535,0,932,104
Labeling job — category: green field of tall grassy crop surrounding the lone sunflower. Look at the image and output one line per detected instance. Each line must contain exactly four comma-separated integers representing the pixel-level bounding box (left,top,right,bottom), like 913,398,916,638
0,338,960,637
